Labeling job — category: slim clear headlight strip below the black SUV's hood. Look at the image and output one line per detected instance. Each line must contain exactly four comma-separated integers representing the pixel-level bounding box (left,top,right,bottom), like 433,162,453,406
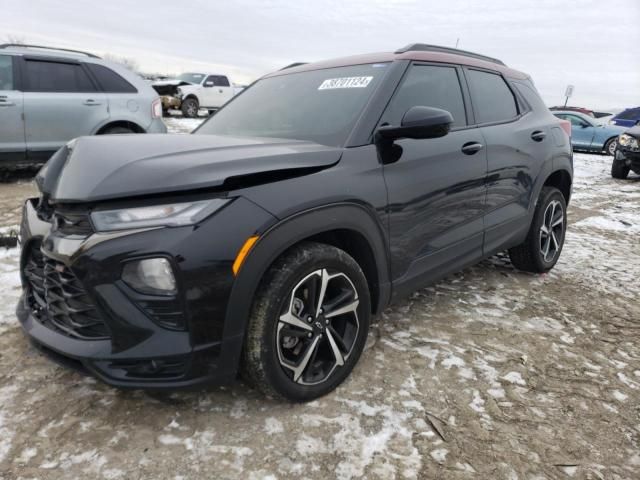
91,198,228,232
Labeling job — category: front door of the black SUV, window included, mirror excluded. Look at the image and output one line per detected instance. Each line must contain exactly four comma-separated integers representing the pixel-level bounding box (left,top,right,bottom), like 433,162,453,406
381,63,487,293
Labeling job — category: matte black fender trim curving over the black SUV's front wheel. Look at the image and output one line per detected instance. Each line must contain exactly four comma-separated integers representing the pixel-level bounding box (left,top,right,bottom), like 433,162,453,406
223,202,391,376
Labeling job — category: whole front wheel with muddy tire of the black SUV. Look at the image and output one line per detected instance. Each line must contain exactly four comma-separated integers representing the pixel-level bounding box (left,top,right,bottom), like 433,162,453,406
241,242,371,402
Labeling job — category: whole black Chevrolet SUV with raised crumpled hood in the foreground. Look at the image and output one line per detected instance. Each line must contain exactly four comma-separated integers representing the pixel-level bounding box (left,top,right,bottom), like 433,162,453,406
17,44,573,401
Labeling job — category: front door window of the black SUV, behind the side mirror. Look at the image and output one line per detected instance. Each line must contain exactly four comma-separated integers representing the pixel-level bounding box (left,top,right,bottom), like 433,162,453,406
383,64,467,127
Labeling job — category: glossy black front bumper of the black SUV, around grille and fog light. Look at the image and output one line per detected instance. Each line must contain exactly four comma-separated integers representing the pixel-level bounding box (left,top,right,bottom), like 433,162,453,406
16,199,270,389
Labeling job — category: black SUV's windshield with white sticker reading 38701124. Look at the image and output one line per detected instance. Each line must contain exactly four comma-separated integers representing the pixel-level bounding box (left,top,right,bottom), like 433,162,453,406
194,63,388,146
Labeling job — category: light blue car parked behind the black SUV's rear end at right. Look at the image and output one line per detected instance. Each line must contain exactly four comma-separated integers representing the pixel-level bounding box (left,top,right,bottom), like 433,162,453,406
552,110,626,155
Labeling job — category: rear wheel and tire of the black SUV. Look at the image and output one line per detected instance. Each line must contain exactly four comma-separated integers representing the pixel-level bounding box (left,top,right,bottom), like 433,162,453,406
509,187,567,273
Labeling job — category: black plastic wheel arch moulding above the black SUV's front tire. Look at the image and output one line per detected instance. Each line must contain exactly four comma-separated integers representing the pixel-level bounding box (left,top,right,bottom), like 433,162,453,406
223,203,391,352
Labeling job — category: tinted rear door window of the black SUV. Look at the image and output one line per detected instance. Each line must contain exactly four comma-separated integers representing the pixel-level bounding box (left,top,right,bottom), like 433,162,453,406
467,70,518,123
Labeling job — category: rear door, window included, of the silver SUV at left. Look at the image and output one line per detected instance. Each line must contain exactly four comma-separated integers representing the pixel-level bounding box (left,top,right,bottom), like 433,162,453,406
22,56,109,160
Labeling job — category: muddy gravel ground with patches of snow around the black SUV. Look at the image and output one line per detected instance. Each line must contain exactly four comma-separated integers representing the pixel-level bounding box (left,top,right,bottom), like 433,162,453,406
0,119,640,480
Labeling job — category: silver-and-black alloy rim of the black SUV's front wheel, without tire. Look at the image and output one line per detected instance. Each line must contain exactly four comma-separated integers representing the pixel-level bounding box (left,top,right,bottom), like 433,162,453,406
276,269,360,385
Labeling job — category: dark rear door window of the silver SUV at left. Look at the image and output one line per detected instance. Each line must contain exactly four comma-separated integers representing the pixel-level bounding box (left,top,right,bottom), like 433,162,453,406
25,59,96,92
